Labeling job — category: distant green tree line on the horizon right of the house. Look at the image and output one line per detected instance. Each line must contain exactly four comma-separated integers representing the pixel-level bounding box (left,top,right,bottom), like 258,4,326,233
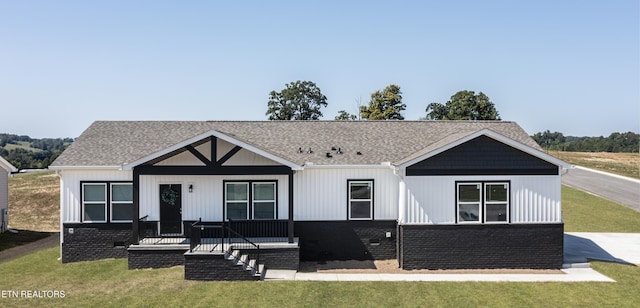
531,130,640,153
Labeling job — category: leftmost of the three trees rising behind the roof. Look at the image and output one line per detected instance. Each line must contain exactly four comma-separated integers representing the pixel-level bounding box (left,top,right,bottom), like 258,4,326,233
265,80,327,120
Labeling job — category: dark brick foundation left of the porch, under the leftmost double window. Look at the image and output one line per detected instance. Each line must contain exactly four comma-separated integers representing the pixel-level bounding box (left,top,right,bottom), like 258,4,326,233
61,224,132,263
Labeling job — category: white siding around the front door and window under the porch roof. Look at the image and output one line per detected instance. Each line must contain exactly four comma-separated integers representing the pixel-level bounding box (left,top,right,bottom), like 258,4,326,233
140,175,289,221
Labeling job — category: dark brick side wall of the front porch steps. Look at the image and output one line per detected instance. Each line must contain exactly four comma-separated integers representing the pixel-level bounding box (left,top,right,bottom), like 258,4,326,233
184,253,259,280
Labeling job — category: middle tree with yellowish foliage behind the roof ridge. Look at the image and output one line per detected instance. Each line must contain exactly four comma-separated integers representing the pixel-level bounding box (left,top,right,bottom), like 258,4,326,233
360,84,407,120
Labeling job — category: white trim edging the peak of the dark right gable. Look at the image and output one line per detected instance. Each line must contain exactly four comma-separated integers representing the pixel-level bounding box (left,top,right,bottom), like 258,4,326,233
398,128,574,169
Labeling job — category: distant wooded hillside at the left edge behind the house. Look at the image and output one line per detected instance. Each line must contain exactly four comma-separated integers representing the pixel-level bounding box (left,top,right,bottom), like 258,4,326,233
0,134,73,169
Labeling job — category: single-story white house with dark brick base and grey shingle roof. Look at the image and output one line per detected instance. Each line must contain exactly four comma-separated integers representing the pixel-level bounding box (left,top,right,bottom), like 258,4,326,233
50,121,571,280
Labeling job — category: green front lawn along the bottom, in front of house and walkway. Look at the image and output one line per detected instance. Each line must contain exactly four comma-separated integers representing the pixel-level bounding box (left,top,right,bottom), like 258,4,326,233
0,248,640,307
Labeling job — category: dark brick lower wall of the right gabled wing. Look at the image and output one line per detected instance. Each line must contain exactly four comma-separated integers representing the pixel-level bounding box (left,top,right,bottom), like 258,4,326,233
398,224,564,269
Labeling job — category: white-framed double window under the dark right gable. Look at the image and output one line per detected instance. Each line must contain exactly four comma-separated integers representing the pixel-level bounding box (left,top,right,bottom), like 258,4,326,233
456,181,511,225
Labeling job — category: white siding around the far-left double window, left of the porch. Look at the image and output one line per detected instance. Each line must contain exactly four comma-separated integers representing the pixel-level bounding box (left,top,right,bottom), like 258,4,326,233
59,169,133,223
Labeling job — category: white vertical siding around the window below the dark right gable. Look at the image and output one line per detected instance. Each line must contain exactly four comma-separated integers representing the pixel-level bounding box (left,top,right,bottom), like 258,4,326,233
400,175,562,224
